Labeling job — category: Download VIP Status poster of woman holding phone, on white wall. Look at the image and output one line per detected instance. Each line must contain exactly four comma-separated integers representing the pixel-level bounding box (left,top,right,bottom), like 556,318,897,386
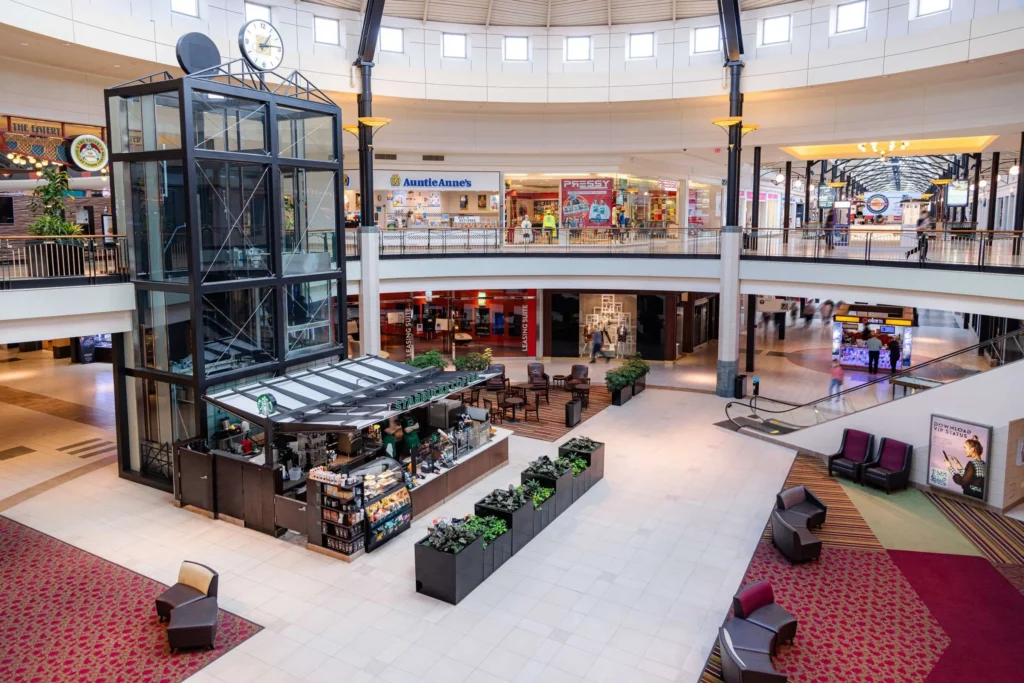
928,415,992,501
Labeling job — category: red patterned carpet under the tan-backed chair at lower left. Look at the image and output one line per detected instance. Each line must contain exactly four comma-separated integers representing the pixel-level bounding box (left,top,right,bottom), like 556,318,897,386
0,516,260,683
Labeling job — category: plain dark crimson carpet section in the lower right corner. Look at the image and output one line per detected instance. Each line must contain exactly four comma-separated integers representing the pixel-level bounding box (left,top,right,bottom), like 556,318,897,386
889,550,1024,683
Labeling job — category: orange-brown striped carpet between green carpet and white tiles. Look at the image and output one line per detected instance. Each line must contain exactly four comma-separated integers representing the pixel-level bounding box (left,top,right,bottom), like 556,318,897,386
763,454,883,550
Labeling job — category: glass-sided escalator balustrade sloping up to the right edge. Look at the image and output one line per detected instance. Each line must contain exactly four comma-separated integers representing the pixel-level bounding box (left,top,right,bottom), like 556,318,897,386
725,329,1024,433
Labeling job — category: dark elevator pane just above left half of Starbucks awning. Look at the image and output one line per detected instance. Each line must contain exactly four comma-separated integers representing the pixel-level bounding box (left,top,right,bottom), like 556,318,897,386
203,287,278,377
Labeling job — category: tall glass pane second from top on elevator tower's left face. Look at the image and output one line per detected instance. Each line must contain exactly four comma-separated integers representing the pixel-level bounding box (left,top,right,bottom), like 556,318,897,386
120,161,188,282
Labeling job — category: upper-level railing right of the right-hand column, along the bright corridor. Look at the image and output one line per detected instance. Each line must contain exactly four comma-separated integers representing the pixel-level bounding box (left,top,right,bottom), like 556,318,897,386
742,229,1024,270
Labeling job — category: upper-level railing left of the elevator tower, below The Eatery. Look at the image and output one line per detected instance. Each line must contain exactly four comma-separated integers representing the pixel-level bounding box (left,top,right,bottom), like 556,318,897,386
0,234,128,289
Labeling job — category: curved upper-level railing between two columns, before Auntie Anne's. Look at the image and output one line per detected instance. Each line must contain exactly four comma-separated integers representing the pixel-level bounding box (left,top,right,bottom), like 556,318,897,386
380,227,721,258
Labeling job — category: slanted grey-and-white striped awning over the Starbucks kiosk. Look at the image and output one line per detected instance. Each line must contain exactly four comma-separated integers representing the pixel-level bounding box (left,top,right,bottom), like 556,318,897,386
203,355,497,432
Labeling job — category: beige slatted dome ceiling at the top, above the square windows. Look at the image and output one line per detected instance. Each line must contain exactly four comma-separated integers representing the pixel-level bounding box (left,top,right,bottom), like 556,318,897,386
306,0,793,27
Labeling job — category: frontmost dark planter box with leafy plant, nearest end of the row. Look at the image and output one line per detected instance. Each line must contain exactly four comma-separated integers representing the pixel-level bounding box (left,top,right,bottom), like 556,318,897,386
415,522,483,605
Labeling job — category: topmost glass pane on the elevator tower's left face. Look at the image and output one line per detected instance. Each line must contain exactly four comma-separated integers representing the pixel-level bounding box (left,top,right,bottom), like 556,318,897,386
108,92,181,154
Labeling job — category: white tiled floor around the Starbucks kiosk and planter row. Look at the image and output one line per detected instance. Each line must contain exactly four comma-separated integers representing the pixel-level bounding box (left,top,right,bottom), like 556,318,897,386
5,390,793,683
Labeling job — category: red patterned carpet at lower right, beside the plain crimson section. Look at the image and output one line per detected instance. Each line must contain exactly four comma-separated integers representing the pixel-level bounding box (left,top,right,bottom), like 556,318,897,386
744,541,942,683
